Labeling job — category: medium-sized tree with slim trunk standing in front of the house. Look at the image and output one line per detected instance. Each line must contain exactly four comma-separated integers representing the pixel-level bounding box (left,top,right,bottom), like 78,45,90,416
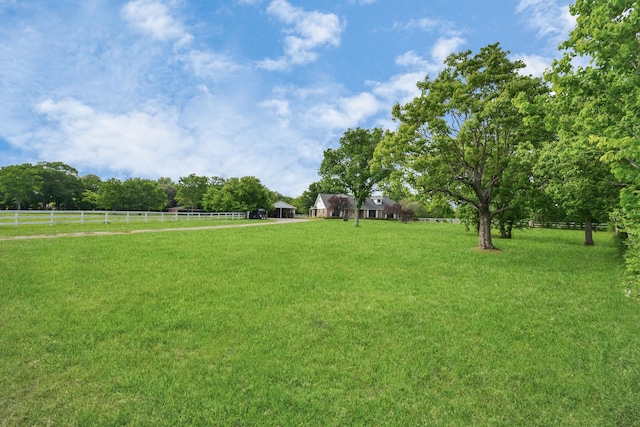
319,128,390,227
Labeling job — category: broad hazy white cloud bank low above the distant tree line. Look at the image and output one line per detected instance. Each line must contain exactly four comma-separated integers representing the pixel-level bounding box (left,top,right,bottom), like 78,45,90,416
29,86,324,196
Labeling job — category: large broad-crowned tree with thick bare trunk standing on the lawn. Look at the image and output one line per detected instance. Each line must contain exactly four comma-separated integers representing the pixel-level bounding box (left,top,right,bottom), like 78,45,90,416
377,44,547,249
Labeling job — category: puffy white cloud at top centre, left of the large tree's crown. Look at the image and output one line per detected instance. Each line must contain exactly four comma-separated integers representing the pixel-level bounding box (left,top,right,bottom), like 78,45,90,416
258,0,342,70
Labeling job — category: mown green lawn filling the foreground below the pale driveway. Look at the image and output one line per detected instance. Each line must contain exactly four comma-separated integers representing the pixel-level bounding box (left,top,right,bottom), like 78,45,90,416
0,221,640,426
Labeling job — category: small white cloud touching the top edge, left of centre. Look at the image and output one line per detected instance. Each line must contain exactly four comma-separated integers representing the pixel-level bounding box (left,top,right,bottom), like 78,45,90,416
122,0,193,46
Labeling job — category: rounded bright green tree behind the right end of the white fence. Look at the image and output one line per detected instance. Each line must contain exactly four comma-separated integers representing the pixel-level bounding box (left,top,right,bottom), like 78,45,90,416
203,176,274,212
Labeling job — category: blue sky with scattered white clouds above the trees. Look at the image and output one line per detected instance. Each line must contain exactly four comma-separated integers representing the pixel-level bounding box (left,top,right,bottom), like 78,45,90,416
0,0,575,197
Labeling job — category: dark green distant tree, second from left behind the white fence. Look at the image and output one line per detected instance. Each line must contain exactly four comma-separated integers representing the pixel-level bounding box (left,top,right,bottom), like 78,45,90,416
36,162,84,209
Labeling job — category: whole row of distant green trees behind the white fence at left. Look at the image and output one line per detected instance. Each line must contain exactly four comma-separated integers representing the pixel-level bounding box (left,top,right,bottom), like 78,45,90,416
0,162,284,216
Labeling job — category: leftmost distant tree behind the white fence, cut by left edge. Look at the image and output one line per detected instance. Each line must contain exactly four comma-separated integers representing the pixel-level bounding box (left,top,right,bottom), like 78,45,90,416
0,163,42,210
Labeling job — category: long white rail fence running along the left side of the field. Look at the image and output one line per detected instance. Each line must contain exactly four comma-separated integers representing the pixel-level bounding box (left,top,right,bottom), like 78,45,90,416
0,210,247,227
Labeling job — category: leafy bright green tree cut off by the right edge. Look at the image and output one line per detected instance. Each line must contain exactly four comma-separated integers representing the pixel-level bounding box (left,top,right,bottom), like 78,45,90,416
547,0,640,276
